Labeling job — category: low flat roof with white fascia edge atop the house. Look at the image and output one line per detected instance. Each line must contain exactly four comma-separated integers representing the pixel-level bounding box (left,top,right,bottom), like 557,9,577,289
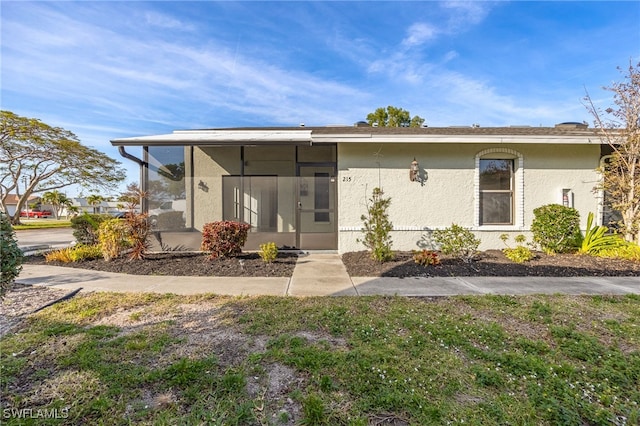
111,126,602,146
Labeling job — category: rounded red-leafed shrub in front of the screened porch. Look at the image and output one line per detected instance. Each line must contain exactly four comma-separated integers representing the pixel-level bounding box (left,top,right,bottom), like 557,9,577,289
200,220,251,259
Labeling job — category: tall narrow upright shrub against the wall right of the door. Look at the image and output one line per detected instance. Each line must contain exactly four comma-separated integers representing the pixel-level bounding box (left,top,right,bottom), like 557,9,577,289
357,188,394,262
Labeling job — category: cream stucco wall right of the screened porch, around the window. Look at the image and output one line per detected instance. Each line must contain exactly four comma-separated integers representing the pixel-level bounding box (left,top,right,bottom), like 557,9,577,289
338,143,600,252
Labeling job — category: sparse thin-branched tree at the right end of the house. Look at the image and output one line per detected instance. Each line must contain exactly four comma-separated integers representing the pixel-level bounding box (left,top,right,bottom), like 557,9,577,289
585,63,640,243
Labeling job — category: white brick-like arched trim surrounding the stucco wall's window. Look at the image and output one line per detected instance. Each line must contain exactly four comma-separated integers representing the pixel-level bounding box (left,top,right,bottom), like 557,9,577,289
473,148,524,230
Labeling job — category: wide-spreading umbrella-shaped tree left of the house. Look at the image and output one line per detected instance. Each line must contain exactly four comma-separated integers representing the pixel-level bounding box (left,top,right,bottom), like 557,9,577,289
0,111,125,224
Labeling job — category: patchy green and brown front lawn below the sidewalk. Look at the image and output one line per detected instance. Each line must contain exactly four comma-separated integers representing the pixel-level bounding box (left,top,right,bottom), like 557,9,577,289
0,293,640,425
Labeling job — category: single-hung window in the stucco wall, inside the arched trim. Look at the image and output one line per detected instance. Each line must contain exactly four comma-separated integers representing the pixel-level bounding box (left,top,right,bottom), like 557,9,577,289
479,159,514,225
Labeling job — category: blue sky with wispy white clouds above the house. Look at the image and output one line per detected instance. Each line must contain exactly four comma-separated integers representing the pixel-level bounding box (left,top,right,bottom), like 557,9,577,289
0,1,640,194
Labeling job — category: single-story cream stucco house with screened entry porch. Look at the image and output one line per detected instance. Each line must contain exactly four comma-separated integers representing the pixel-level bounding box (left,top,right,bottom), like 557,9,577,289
111,122,609,253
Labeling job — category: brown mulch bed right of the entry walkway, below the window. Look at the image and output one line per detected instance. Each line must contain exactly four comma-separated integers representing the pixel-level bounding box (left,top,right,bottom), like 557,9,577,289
342,250,640,277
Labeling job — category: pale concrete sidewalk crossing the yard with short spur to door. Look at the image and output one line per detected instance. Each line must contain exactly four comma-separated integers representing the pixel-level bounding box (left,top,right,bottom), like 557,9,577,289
16,253,640,296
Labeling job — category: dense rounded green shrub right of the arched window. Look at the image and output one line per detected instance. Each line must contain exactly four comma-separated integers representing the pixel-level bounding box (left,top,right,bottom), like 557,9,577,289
531,204,580,254
